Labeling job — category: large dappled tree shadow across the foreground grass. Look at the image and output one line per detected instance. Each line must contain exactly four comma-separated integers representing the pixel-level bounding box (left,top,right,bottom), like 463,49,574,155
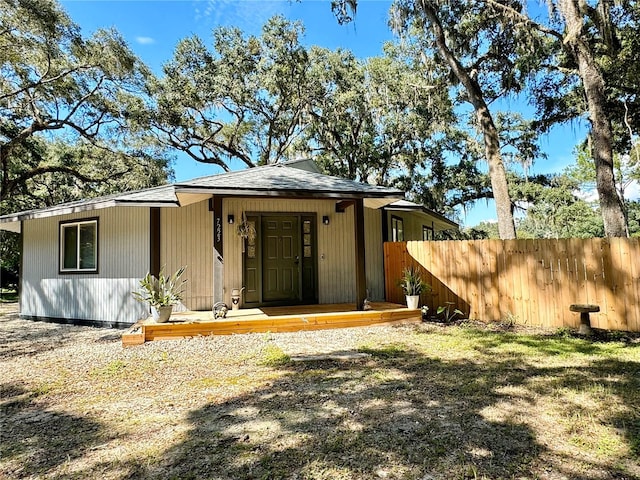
112,338,640,480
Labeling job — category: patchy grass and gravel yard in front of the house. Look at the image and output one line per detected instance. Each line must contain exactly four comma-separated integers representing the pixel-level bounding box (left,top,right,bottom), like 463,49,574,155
0,304,640,480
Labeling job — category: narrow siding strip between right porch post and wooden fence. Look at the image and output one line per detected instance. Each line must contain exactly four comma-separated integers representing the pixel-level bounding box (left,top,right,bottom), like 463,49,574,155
364,208,384,301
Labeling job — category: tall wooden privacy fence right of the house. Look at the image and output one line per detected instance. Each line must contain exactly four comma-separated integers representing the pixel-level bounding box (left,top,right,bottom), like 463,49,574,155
384,238,640,332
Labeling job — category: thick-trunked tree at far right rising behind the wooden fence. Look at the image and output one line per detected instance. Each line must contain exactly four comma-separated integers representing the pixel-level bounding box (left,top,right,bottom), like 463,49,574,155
487,0,640,237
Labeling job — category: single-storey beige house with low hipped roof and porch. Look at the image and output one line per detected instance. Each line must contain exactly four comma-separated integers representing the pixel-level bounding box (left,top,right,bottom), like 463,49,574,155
0,160,457,326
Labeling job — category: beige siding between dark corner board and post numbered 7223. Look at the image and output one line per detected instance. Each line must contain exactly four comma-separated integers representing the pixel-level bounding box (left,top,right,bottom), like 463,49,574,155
160,200,213,310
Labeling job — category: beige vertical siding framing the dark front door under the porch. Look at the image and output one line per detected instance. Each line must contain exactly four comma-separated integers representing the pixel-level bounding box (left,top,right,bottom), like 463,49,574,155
222,198,364,304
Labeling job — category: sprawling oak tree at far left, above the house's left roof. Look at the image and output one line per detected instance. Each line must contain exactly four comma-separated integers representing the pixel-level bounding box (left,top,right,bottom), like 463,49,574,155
0,0,171,273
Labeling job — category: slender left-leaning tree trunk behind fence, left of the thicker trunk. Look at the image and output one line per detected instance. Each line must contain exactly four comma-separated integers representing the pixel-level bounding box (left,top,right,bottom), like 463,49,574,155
420,0,516,239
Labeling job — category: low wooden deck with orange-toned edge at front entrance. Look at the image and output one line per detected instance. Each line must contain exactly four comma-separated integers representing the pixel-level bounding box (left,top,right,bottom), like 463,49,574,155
122,302,420,347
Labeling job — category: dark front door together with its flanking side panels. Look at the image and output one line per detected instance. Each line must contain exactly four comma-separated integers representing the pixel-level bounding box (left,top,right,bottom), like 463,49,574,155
243,214,317,305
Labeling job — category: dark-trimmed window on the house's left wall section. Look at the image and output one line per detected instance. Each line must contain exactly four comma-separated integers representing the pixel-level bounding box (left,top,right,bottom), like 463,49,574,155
60,219,98,273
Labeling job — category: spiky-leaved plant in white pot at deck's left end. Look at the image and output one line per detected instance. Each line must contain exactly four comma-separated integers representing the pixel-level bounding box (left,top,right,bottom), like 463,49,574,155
132,267,186,323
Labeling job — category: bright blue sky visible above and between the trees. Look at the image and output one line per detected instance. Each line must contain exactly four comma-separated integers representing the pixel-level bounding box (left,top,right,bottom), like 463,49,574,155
61,0,584,226
